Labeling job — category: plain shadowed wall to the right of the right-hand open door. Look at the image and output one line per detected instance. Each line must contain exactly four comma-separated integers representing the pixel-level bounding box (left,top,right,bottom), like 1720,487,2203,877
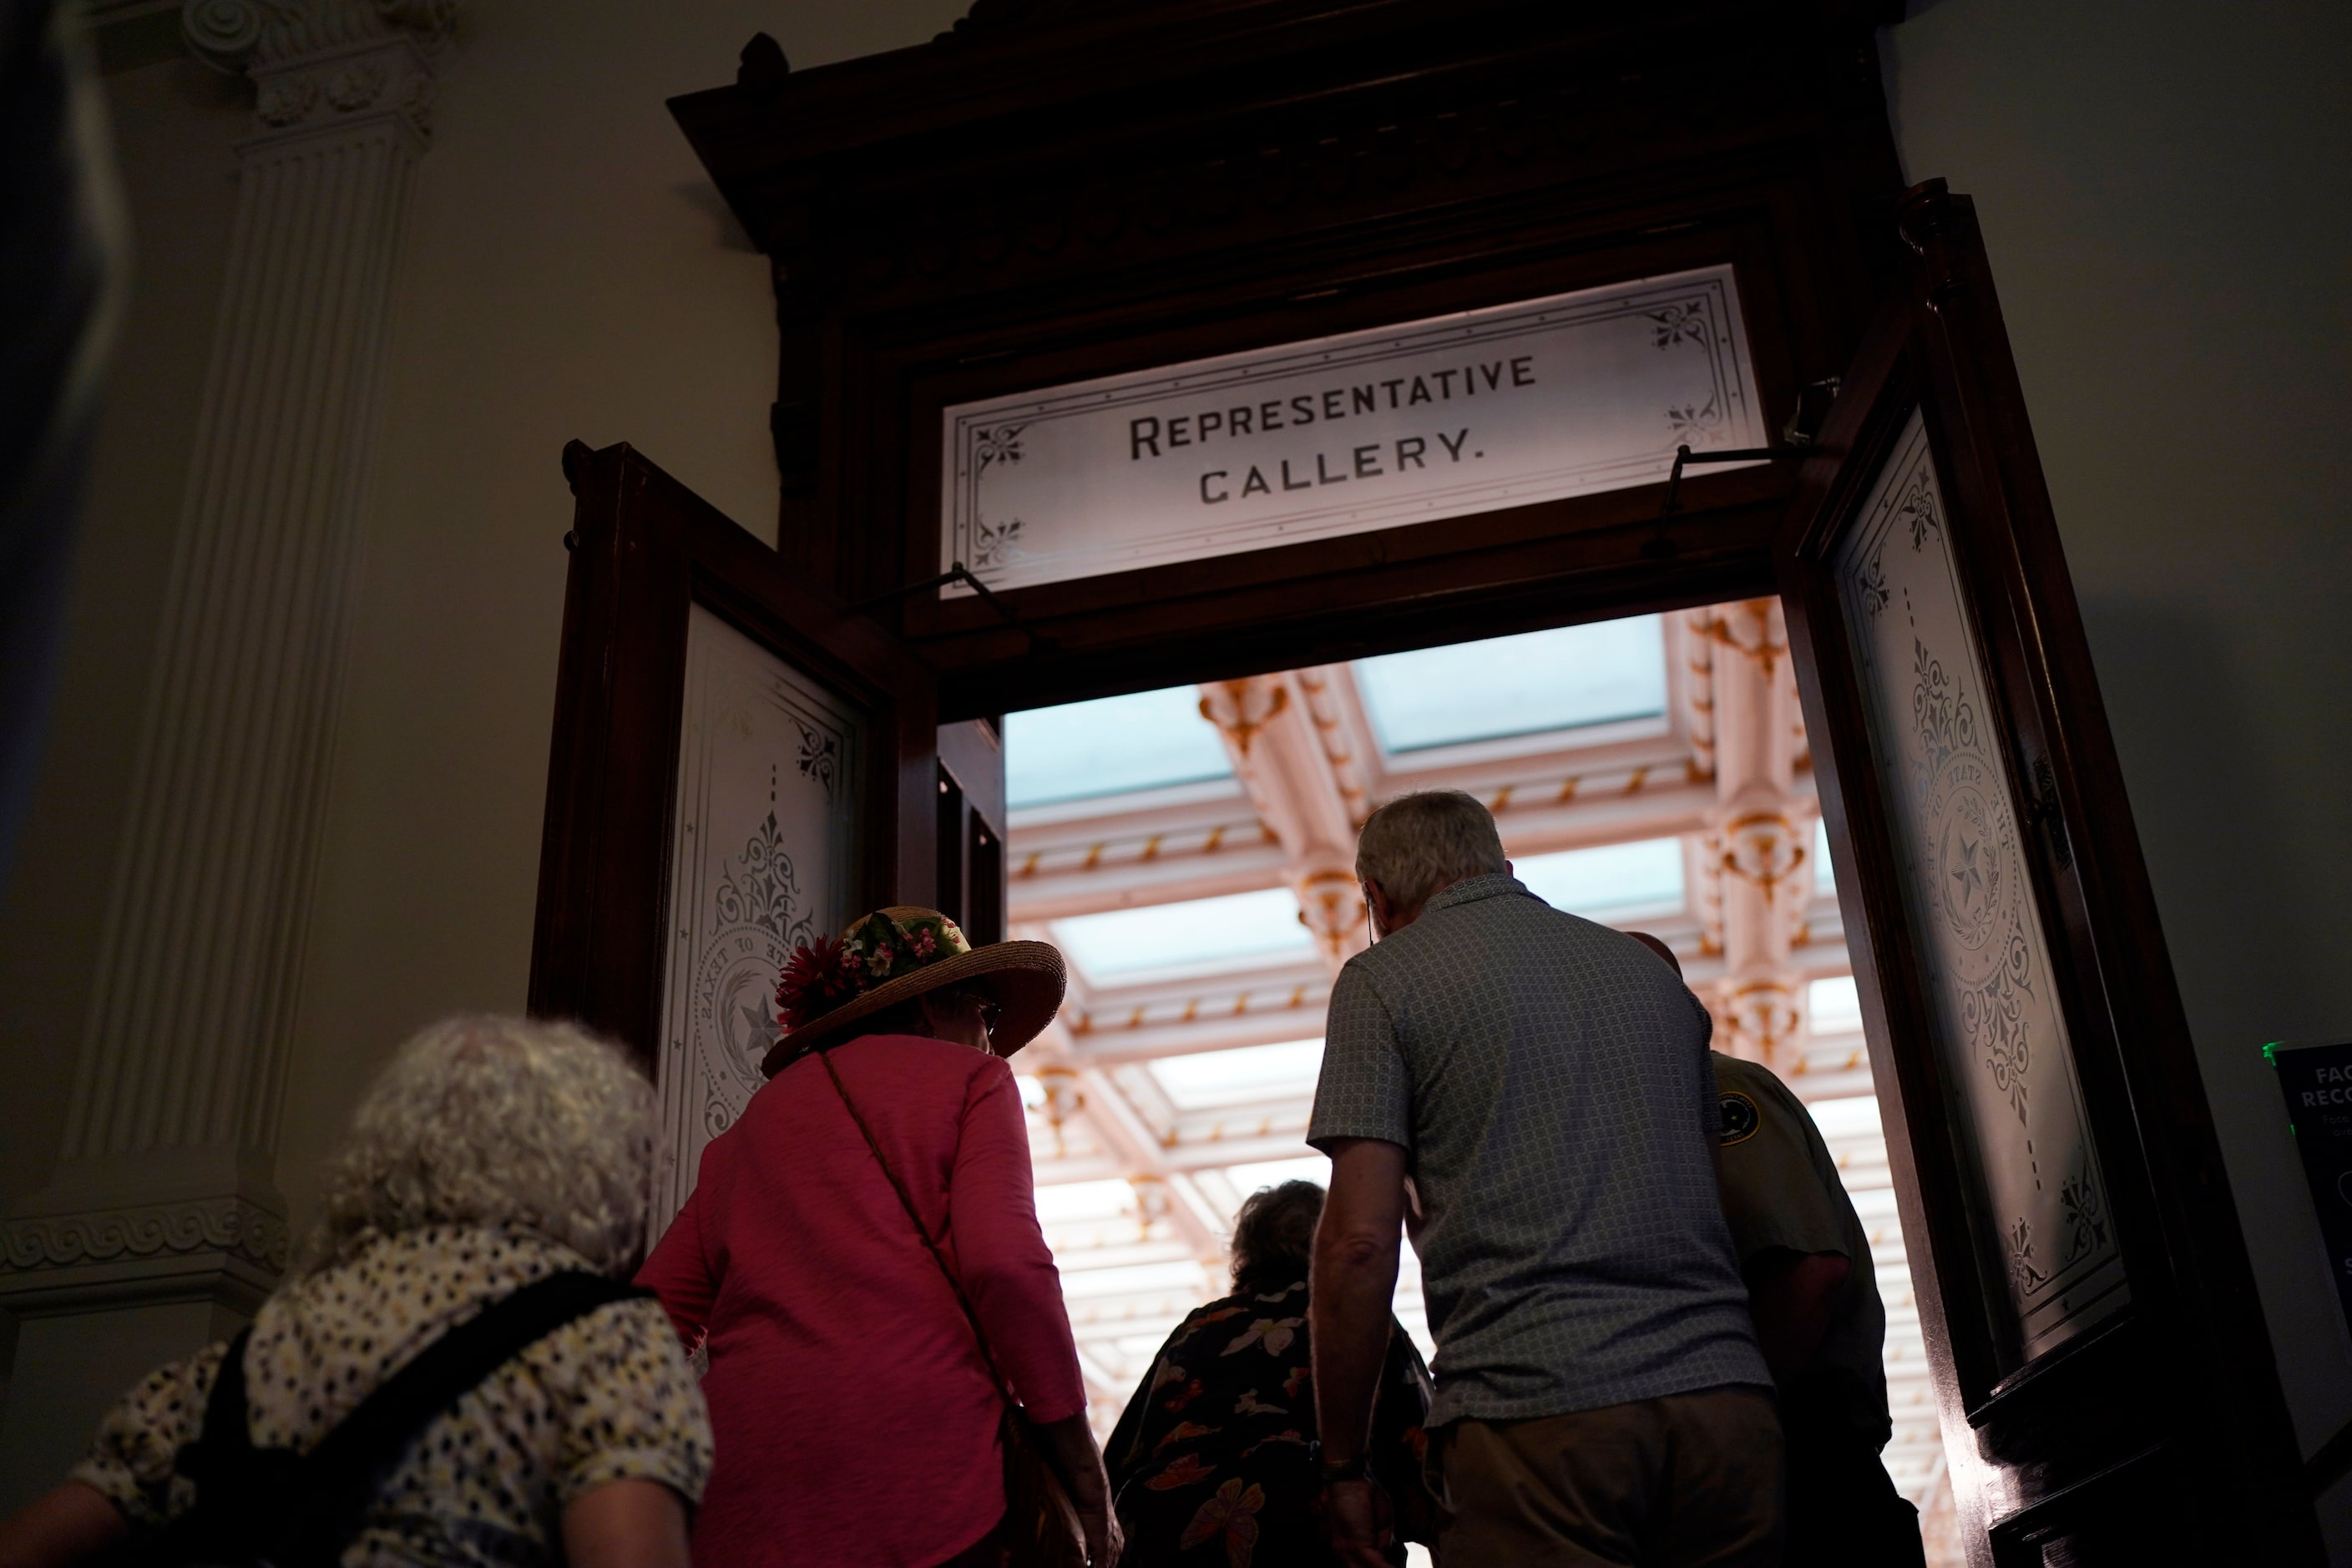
1884,0,2352,1561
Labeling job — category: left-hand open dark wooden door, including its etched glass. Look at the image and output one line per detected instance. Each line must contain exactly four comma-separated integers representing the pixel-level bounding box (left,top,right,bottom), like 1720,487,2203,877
529,442,936,1225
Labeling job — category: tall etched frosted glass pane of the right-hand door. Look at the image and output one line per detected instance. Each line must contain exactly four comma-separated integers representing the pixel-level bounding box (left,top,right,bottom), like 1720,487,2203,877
1830,412,2128,1363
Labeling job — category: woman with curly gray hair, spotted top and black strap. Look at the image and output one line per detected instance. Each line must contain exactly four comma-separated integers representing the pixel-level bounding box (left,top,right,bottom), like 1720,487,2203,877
0,1018,711,1568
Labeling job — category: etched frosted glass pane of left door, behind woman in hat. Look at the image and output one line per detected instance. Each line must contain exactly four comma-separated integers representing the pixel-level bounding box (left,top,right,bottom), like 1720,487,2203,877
654,604,866,1232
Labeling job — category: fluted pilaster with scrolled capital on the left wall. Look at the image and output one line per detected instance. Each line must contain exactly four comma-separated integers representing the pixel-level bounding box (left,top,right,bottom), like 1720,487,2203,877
0,0,452,1312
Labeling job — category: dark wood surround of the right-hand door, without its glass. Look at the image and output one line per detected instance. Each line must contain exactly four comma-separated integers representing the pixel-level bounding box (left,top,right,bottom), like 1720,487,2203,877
1780,181,2319,1565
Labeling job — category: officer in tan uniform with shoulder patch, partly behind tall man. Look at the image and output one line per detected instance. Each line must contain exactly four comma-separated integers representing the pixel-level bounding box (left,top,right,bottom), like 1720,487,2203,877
1635,933,1926,1568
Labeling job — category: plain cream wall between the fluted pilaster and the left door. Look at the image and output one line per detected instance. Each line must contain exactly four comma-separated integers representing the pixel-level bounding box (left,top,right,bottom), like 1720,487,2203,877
277,0,964,1232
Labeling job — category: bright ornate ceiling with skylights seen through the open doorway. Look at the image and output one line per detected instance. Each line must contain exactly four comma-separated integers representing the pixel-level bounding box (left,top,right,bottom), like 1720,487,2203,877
1004,599,1966,1565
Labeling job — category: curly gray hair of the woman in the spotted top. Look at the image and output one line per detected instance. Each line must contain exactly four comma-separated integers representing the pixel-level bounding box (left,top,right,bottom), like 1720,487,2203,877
303,1018,654,1274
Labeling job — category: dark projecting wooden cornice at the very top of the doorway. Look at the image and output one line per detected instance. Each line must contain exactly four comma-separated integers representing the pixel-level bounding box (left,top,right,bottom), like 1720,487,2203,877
670,0,1884,311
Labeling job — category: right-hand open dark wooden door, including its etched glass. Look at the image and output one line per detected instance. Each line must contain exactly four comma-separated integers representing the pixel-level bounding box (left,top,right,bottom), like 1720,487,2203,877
1776,181,2321,1568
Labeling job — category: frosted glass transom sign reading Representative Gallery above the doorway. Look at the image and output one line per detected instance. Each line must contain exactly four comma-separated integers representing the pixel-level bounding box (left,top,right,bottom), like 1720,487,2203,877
938,266,1767,588
